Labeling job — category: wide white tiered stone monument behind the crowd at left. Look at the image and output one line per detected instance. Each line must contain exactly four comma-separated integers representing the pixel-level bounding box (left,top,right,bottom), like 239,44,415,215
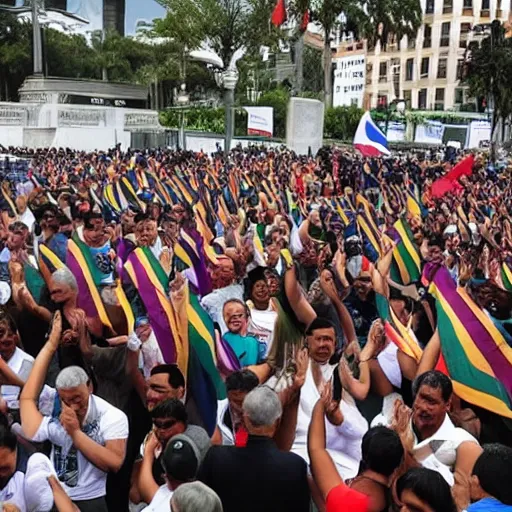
0,76,165,151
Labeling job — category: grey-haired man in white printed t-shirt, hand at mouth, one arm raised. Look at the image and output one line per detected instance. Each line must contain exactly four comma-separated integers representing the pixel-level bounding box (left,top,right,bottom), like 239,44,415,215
20,312,128,512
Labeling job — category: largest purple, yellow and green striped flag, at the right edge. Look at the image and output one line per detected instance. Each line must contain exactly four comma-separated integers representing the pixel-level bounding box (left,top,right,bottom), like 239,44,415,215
424,265,512,418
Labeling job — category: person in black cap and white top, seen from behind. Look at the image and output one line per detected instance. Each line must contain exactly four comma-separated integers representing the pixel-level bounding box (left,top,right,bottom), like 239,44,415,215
141,425,210,512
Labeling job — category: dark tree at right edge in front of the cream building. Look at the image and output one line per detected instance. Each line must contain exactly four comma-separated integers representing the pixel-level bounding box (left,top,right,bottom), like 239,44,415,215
462,20,512,144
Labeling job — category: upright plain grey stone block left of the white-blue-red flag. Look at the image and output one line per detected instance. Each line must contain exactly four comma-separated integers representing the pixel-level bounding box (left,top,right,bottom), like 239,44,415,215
286,98,324,155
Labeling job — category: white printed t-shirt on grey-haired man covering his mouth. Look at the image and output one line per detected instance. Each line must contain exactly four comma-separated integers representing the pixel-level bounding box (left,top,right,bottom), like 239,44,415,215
32,395,128,501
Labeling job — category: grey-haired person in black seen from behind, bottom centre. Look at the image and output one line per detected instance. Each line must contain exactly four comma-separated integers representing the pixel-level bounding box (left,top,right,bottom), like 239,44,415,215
198,386,310,512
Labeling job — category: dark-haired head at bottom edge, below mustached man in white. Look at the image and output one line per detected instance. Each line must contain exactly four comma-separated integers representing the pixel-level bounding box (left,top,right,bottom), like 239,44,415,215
396,467,457,512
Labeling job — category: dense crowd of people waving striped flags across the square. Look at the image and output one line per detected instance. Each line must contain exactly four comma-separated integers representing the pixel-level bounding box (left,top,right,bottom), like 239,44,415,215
0,147,512,512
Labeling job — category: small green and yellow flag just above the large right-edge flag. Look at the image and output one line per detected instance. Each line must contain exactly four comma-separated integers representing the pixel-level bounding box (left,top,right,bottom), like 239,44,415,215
390,217,421,286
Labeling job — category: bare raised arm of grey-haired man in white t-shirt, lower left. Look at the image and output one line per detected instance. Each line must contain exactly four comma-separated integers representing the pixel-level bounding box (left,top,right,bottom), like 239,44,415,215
20,311,62,438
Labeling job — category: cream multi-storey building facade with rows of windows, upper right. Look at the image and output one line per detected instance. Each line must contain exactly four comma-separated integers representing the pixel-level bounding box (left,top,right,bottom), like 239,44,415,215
365,0,512,110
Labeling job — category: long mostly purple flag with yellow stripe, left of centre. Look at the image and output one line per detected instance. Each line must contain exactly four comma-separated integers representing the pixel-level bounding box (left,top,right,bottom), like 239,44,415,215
124,247,183,362
